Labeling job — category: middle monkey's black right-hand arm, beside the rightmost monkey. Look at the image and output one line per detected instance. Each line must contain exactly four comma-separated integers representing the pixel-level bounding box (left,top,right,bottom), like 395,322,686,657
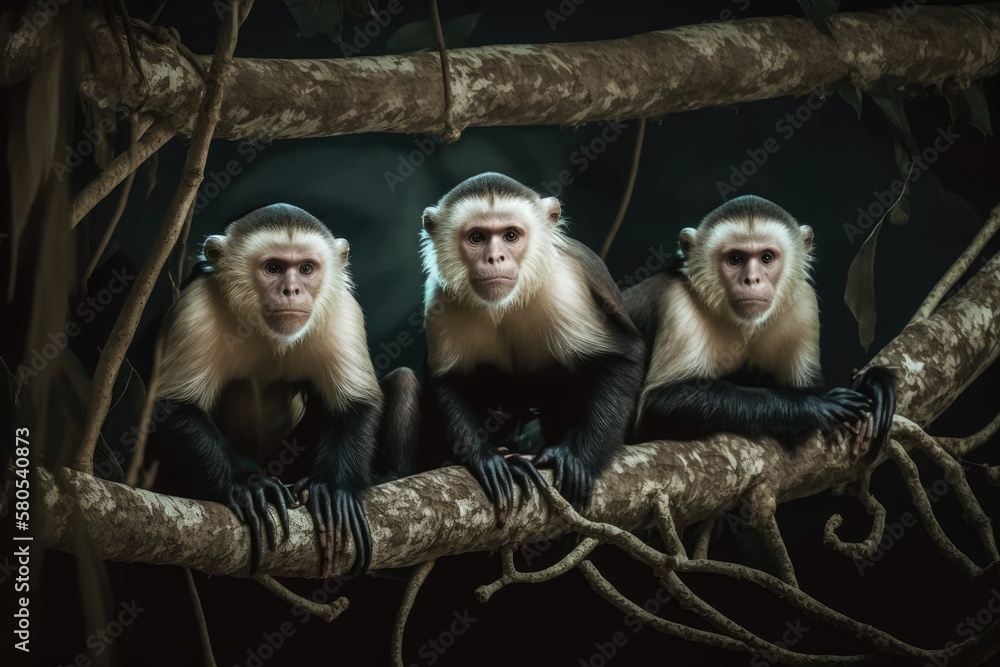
534,348,645,509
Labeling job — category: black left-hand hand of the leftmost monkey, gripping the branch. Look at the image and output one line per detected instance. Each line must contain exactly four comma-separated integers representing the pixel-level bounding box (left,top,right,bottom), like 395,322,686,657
220,472,291,574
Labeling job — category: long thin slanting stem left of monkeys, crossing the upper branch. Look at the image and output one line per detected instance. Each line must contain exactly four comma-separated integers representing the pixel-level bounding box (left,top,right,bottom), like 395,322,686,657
73,0,253,473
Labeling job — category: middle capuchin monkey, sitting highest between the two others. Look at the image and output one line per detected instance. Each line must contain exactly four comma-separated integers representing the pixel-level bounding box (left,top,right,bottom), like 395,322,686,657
421,173,645,524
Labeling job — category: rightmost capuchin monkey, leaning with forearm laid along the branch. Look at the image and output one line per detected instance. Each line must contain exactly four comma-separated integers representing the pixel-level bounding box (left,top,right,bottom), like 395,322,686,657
622,195,895,460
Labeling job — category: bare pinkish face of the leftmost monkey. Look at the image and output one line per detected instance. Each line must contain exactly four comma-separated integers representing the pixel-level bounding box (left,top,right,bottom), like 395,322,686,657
251,245,323,336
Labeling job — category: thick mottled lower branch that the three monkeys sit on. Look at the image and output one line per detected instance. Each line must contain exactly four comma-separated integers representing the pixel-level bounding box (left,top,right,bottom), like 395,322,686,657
23,250,1000,577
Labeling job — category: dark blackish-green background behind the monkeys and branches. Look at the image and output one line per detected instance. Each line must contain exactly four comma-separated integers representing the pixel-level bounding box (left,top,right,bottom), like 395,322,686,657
7,0,1000,666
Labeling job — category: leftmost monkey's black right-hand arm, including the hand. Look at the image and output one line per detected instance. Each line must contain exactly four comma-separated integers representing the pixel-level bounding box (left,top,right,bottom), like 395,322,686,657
294,401,382,577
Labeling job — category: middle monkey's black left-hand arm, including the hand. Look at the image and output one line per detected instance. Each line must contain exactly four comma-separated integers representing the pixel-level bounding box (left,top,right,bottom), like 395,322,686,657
428,373,546,525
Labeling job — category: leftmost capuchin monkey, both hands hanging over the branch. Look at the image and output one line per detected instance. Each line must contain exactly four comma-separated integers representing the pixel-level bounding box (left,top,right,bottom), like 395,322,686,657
154,204,419,575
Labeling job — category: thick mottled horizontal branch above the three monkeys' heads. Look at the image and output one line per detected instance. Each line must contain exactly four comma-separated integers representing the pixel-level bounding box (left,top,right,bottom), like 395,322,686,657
0,5,1000,139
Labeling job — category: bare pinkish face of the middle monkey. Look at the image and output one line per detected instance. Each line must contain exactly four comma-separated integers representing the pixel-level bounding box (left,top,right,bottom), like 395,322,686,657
456,214,528,302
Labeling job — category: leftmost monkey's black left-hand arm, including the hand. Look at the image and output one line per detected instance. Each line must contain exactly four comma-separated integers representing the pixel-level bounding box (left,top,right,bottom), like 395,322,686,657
157,401,288,574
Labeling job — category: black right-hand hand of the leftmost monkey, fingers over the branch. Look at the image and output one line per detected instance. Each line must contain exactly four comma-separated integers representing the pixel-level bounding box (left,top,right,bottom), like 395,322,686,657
293,477,372,577
